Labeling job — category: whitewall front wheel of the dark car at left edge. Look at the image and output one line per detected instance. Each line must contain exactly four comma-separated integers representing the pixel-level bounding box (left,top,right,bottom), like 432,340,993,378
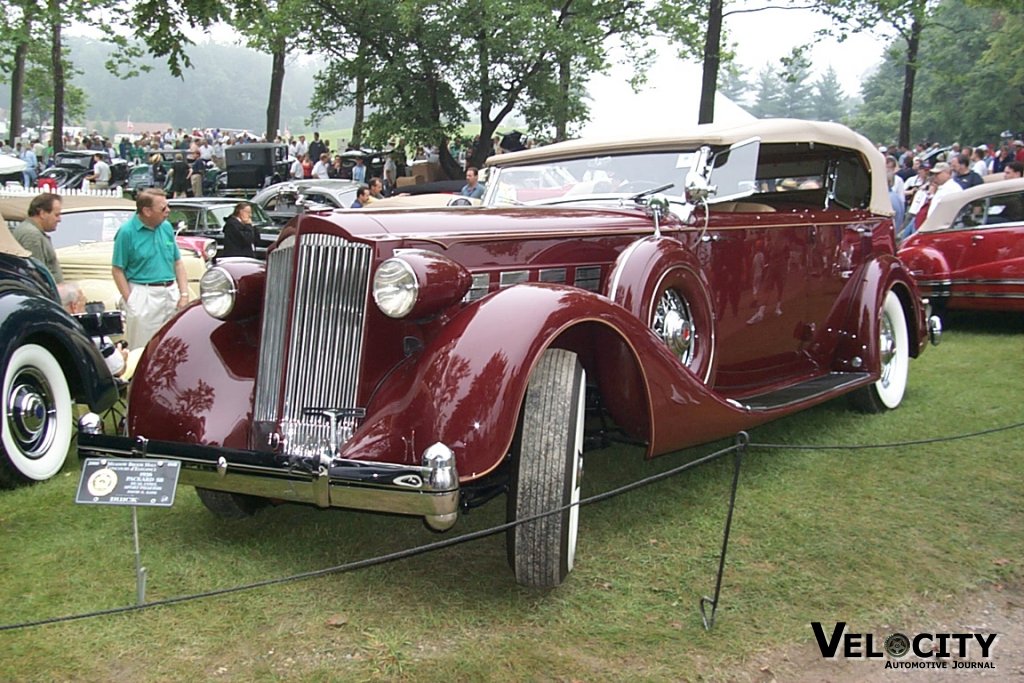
0,344,74,487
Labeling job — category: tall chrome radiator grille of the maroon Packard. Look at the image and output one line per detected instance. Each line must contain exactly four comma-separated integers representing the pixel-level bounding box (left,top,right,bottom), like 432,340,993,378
253,234,373,452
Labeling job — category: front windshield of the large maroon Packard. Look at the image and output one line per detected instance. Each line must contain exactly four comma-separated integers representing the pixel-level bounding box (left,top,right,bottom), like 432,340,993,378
483,152,693,206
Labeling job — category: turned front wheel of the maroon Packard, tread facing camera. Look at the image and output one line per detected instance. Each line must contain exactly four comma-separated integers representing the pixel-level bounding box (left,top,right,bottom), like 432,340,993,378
506,349,586,588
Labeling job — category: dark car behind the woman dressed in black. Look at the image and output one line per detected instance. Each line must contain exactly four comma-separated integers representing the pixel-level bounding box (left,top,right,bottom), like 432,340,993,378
167,197,281,261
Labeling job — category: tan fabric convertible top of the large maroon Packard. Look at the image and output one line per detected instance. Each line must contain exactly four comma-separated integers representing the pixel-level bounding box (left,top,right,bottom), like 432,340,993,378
486,119,893,215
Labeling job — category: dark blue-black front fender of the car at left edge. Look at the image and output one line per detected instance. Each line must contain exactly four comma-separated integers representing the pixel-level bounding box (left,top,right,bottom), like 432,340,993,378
0,291,118,413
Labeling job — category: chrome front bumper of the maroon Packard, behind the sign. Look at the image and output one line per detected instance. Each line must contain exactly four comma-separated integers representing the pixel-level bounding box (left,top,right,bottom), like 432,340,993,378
78,414,459,530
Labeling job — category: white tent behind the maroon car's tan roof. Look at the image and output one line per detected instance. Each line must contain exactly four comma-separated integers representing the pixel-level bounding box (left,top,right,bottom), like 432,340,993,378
580,56,756,137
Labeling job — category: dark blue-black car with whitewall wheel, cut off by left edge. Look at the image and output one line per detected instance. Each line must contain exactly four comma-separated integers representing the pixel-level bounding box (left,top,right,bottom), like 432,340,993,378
0,219,118,487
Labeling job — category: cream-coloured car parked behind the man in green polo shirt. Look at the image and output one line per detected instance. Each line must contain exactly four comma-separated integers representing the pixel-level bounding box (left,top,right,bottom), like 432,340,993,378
0,193,209,311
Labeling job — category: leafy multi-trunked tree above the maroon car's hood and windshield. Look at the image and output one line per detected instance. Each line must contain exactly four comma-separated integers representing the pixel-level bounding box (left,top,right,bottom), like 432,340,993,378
313,0,653,176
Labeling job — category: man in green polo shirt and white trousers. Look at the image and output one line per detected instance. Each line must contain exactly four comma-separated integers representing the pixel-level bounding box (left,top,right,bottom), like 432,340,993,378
111,189,188,348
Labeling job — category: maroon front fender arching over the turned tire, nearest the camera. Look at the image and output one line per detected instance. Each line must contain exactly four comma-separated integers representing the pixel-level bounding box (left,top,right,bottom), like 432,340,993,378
342,284,750,480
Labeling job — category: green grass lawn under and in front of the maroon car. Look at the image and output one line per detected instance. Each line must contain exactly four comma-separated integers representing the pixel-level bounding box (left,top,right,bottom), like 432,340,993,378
0,315,1024,682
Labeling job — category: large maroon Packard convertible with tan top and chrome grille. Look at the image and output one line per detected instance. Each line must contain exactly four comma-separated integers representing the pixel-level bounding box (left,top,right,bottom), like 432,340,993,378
79,120,939,587
